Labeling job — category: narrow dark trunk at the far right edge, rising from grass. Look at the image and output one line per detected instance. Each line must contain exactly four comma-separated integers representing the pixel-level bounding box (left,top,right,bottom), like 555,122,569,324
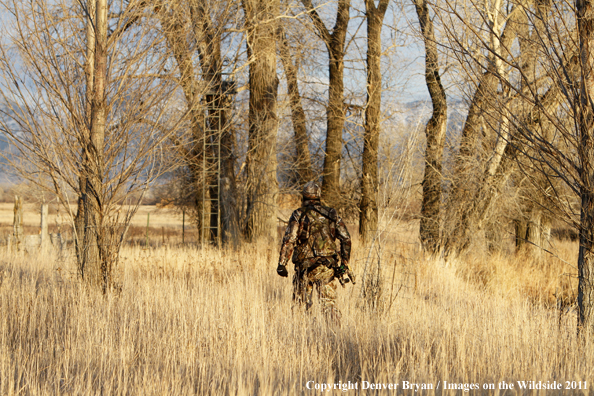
576,0,594,333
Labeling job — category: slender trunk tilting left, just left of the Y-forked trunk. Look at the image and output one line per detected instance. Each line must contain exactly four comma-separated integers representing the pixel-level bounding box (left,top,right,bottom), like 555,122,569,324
278,28,314,187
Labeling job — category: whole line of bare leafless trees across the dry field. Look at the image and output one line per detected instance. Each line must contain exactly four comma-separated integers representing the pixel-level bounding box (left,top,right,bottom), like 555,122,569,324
0,0,594,328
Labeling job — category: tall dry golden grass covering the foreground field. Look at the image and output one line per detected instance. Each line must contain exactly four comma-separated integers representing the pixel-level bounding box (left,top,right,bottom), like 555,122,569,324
0,237,594,395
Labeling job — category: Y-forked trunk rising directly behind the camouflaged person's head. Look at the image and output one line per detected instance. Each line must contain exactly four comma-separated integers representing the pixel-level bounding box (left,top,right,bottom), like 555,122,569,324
301,0,351,207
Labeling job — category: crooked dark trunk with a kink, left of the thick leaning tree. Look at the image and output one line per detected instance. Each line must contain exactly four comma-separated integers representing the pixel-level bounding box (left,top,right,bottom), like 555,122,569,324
415,0,447,253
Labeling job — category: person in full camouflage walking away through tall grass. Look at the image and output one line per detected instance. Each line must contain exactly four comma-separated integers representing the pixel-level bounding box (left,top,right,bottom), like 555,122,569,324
276,182,355,320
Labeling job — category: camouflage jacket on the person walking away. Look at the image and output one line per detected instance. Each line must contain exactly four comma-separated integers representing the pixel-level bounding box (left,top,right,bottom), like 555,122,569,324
279,200,351,265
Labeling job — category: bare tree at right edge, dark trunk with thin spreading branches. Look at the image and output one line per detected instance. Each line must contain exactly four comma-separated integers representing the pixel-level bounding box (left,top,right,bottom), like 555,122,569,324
432,0,594,332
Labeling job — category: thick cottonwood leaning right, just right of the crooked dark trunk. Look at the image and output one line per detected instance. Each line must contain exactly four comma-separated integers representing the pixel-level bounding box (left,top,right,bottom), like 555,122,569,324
436,0,526,254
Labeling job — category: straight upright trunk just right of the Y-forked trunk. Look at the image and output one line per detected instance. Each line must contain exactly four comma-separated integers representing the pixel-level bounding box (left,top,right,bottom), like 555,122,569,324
359,0,389,243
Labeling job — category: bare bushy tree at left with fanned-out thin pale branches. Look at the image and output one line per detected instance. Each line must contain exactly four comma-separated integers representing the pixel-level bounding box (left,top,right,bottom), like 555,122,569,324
0,0,175,291
